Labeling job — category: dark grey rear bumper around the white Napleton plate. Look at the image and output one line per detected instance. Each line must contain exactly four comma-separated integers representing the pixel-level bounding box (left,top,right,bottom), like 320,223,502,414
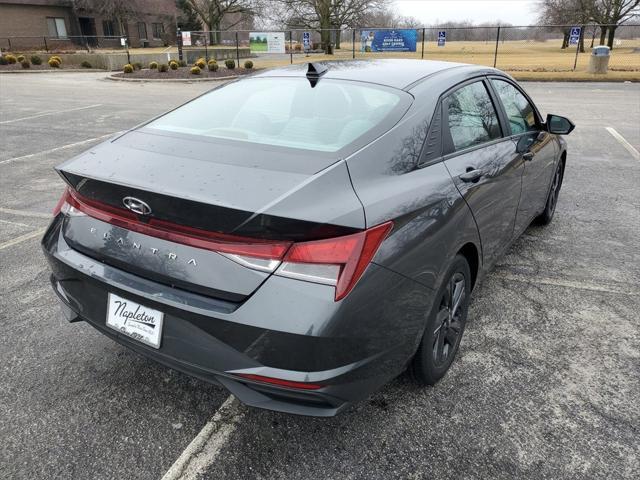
43,219,430,416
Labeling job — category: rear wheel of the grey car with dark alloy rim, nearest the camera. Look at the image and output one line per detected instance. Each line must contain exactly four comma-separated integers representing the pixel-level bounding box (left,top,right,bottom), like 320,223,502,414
410,255,471,385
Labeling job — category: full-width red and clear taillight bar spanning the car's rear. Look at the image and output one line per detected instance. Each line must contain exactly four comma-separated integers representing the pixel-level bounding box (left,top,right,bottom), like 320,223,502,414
53,188,393,301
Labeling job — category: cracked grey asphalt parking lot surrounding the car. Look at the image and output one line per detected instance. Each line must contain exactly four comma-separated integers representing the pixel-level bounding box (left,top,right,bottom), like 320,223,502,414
0,73,640,479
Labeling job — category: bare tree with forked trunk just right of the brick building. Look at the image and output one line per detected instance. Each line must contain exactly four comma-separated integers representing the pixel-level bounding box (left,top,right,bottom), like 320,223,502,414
184,0,258,43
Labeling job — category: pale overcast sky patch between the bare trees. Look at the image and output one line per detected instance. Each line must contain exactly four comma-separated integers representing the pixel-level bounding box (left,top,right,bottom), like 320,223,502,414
395,0,537,25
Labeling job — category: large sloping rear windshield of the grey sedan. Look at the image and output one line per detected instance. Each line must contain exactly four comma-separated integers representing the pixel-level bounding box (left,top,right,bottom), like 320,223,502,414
145,77,401,152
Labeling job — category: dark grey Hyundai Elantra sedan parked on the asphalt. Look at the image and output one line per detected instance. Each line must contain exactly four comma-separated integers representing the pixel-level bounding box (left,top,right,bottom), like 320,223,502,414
42,60,574,416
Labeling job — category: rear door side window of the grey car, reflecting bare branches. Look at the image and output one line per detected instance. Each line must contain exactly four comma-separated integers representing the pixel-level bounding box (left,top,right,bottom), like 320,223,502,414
444,81,502,151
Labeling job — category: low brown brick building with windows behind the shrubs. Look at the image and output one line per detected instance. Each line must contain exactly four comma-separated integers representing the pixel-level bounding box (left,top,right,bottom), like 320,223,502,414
0,0,177,48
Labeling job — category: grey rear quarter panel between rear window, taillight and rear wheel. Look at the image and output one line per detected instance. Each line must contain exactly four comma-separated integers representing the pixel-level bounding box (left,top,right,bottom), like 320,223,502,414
347,106,481,289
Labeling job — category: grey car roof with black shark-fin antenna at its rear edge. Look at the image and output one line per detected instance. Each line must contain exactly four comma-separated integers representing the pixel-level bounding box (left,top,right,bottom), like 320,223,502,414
254,59,502,90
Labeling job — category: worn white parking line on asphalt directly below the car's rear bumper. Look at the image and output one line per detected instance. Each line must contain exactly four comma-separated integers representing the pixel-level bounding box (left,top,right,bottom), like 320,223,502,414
162,395,244,480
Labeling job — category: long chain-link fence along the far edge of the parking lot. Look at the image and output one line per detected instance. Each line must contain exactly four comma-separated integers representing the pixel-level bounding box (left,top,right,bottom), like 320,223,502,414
0,25,640,72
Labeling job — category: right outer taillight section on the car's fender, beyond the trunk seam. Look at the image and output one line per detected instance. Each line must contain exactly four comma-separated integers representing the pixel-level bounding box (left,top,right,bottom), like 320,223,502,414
277,222,393,301
